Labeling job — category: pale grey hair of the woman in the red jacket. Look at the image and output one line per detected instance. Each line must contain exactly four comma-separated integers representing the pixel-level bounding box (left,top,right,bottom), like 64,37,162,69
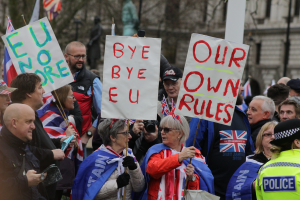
160,115,190,144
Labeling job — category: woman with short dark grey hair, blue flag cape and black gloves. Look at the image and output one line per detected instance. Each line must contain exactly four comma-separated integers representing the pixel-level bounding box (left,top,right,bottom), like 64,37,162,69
72,119,145,200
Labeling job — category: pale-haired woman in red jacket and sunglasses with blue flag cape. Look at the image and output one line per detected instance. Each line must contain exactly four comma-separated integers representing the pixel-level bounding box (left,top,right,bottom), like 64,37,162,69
138,115,214,200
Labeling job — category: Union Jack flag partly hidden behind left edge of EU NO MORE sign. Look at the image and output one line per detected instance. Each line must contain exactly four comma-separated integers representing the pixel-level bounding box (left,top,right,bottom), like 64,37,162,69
4,18,18,86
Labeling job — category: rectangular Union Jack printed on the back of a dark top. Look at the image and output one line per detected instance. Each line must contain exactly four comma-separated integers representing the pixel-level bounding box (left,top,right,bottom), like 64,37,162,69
219,130,247,153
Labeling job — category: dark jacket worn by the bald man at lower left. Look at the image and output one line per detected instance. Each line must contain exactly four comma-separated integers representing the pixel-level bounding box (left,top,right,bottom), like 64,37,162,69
0,126,53,200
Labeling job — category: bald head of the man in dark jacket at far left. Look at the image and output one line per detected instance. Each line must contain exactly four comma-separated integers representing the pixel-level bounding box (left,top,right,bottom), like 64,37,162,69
3,103,35,142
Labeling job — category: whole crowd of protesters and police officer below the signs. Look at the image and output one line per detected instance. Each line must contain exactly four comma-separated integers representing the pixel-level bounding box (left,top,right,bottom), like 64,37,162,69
0,39,300,200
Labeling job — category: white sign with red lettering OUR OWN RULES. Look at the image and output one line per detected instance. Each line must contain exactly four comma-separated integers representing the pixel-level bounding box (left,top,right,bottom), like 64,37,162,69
175,34,249,125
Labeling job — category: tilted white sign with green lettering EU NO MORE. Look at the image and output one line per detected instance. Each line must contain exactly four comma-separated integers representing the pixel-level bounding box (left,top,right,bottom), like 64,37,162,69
2,17,74,93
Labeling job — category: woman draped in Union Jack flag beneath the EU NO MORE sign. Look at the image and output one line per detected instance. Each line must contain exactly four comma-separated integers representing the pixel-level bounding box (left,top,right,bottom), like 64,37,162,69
38,85,83,200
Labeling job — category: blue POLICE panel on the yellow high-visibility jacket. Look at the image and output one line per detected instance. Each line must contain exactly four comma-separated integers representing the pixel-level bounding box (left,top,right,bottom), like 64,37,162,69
262,176,296,192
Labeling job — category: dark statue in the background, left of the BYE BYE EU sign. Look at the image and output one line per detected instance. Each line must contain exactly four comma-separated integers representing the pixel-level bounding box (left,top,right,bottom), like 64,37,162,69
87,16,102,69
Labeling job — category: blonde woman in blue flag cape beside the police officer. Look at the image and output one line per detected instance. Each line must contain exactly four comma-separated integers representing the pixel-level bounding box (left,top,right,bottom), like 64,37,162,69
226,121,277,200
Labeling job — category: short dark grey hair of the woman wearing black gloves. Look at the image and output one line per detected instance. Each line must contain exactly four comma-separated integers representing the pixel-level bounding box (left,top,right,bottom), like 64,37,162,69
98,119,126,145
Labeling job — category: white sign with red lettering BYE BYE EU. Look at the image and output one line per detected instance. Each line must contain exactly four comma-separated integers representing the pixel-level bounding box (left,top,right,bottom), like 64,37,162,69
101,35,161,120
